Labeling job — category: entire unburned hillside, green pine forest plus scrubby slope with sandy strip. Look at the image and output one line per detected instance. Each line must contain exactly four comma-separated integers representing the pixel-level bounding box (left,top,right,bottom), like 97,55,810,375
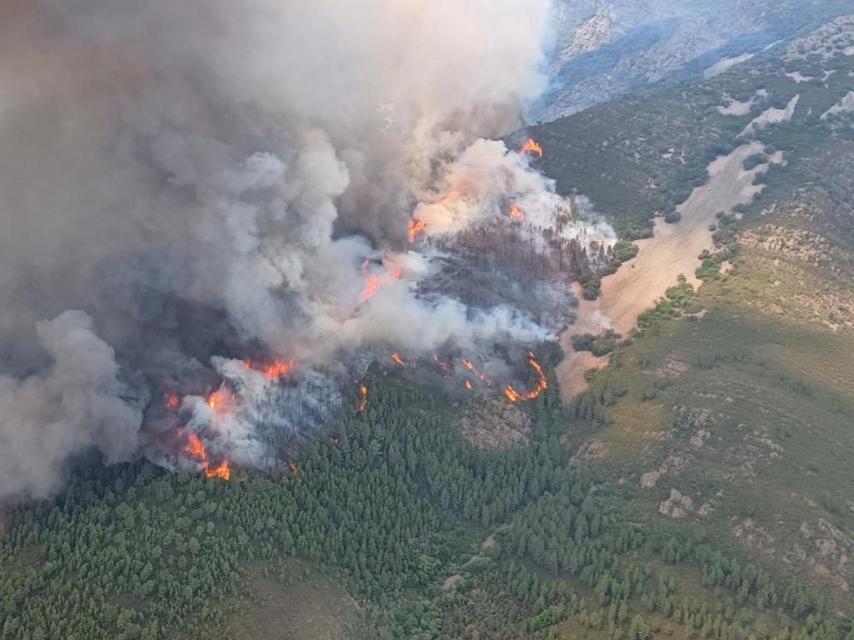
0,11,854,640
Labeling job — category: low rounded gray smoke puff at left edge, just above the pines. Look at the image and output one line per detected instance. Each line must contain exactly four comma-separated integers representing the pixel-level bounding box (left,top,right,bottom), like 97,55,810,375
0,311,143,499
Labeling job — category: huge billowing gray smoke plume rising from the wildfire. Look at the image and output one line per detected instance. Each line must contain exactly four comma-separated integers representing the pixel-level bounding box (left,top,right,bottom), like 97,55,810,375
0,0,611,495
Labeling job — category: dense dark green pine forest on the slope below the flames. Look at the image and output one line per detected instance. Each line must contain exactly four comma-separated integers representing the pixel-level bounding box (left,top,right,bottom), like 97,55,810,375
0,350,854,640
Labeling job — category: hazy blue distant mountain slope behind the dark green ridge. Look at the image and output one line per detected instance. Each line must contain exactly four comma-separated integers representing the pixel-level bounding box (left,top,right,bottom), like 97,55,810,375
532,0,852,121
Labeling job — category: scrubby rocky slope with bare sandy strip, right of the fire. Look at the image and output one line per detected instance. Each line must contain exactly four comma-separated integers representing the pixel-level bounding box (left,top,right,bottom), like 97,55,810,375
536,13,854,604
